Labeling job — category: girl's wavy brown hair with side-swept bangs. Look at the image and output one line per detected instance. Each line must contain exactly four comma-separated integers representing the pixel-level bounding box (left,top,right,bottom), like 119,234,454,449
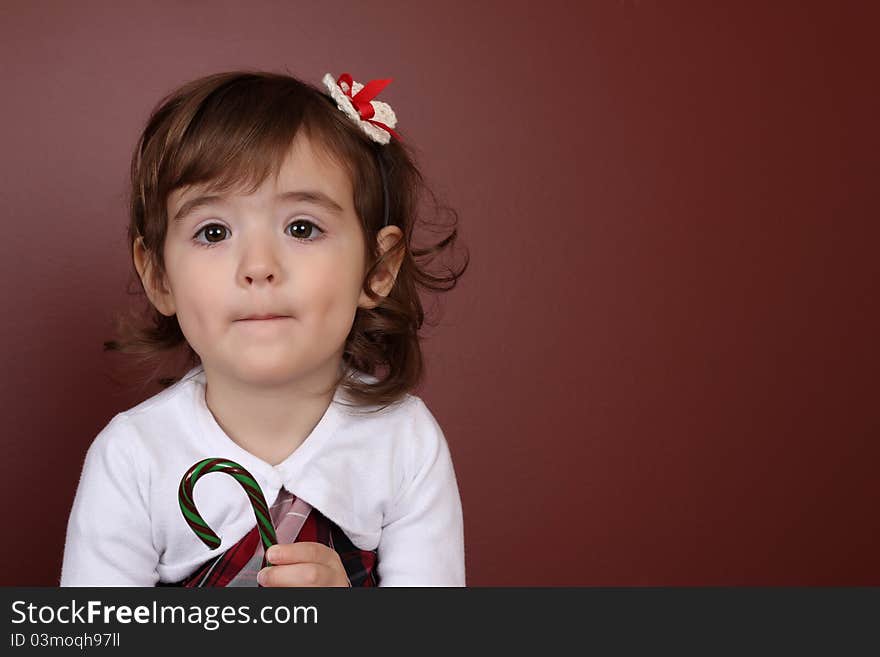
104,71,469,408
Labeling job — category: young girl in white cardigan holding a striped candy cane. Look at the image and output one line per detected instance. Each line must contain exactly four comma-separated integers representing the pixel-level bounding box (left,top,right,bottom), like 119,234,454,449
61,72,467,586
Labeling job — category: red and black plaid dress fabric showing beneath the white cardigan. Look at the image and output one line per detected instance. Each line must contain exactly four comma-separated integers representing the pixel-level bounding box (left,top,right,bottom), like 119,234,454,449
157,498,379,587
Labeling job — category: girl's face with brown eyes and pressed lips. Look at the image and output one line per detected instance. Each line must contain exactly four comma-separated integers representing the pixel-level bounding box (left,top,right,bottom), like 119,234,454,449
154,132,375,385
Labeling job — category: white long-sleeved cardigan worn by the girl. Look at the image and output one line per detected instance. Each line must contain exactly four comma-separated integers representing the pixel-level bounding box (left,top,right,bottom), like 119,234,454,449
61,366,465,586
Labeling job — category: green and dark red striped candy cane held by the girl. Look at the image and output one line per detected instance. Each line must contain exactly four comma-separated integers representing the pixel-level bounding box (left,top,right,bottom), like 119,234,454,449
177,458,278,567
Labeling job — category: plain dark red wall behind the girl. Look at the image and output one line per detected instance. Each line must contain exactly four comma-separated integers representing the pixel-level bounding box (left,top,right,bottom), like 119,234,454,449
0,0,880,585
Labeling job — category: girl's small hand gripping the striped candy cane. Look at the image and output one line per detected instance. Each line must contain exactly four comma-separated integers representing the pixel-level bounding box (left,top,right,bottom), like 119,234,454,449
257,542,351,587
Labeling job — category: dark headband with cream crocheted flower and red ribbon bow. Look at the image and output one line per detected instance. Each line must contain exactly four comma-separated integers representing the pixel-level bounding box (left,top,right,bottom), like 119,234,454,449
323,73,401,227
